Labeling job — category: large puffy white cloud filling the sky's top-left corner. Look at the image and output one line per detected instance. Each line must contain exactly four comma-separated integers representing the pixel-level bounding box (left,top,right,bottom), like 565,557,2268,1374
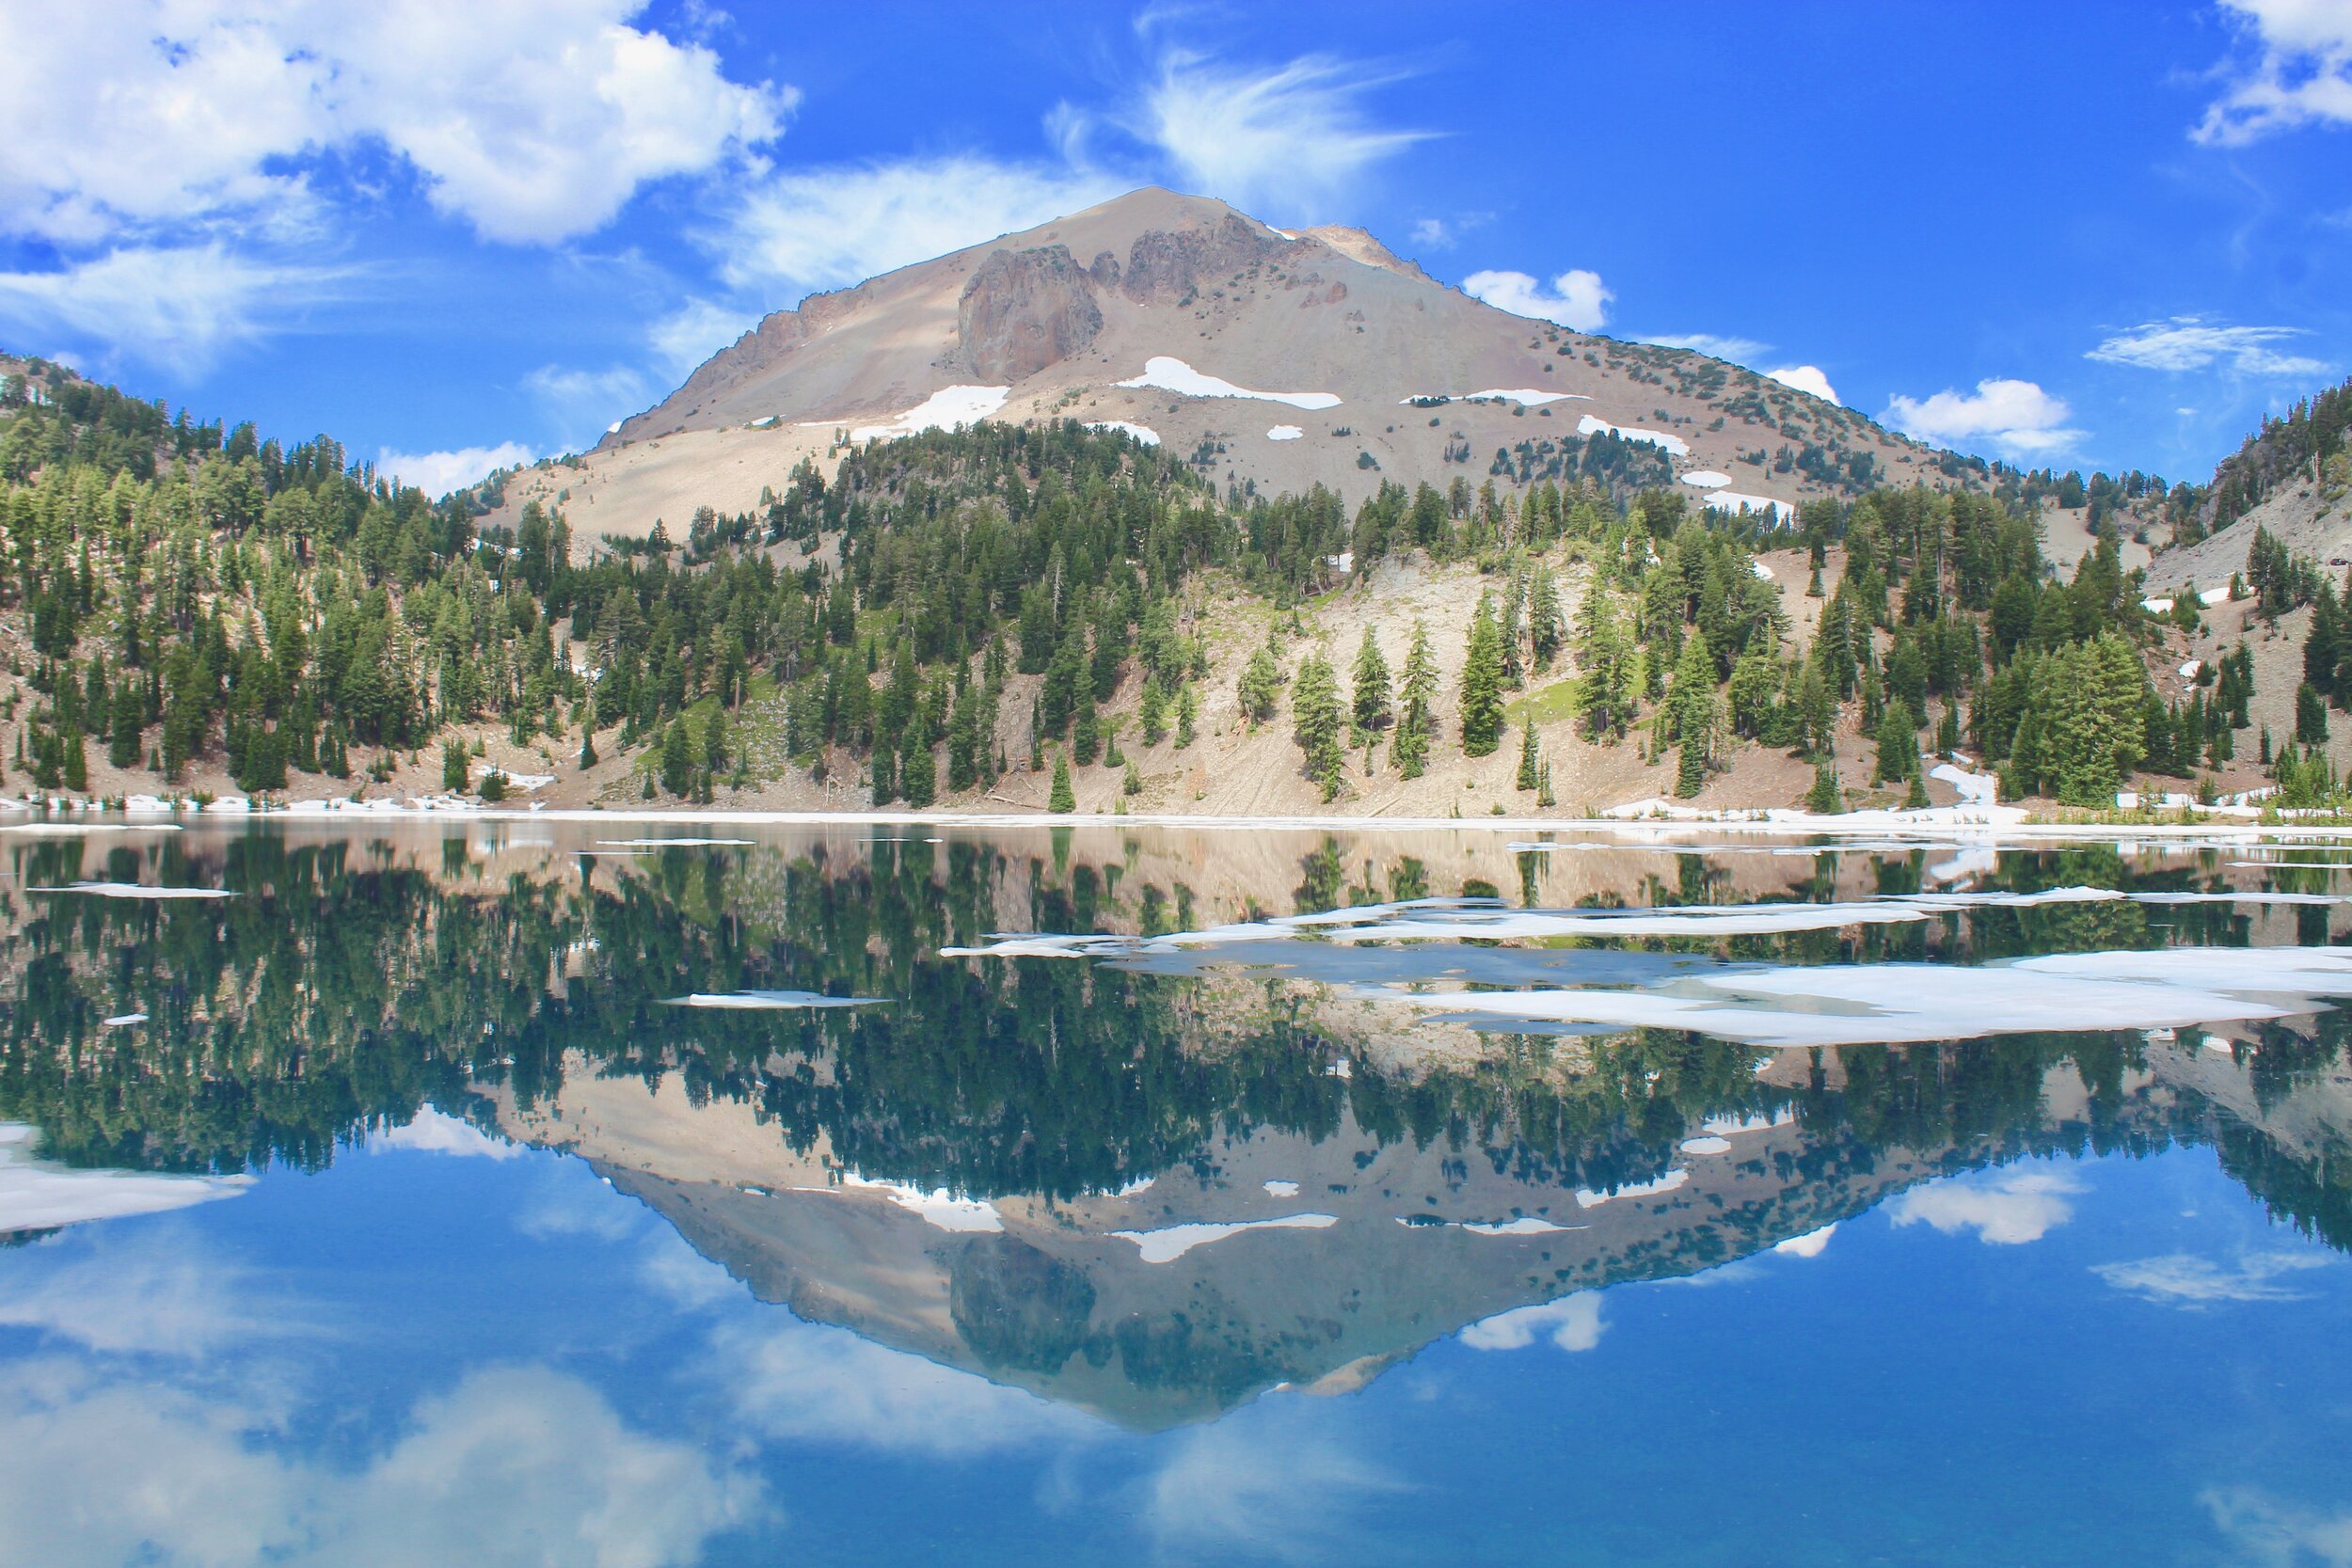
0,0,795,245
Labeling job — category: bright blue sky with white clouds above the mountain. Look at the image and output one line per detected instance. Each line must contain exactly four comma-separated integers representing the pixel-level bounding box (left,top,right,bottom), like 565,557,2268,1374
0,0,2352,486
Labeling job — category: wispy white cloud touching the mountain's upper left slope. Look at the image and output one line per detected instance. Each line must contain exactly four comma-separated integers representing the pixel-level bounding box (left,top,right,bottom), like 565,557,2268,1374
701,155,1124,293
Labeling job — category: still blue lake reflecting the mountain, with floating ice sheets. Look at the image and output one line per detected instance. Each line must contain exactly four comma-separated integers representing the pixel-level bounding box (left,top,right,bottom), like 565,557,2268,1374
0,820,2352,1568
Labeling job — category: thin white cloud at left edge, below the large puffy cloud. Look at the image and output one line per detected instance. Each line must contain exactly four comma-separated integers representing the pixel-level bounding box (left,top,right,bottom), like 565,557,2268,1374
0,242,356,372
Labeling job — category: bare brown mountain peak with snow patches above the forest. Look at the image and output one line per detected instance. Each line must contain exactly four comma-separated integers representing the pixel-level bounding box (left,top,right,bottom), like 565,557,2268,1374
486,190,1983,538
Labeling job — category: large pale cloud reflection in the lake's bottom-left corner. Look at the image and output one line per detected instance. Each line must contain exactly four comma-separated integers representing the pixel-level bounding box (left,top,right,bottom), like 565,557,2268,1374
0,1364,765,1568
